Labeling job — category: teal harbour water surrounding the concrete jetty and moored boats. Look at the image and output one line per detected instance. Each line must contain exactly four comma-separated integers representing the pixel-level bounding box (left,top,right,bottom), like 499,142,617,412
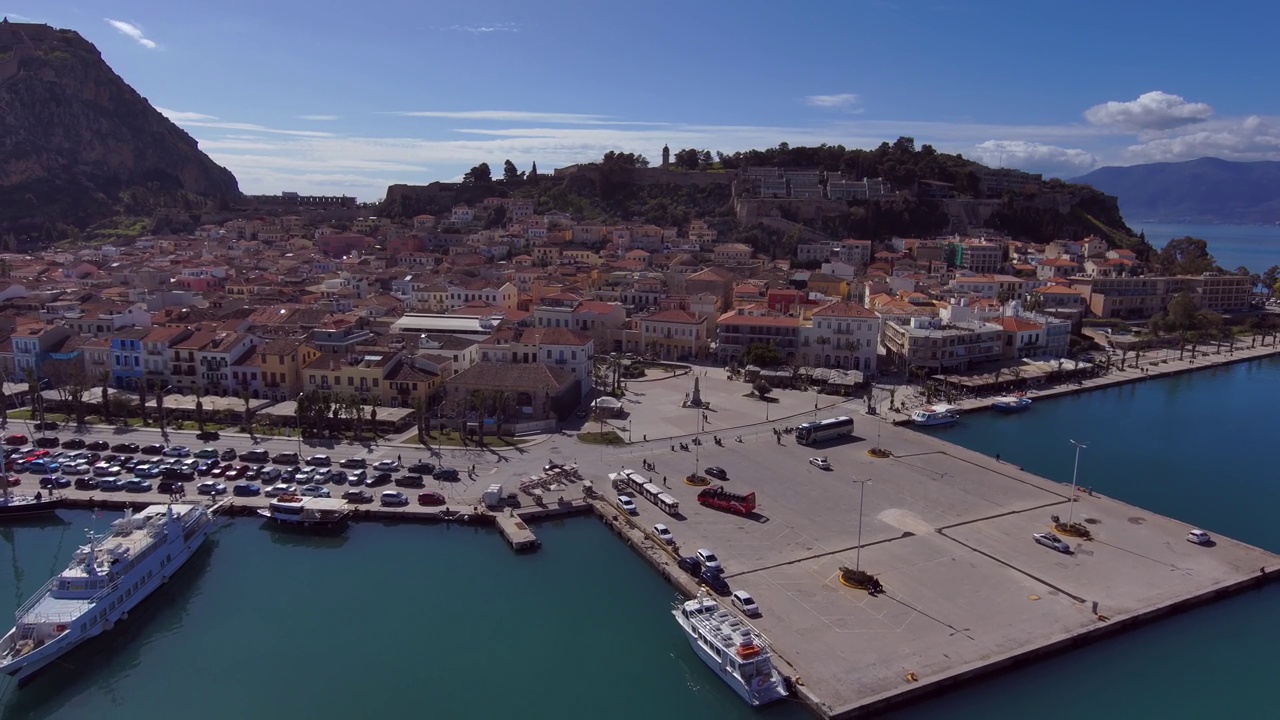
0,359,1280,720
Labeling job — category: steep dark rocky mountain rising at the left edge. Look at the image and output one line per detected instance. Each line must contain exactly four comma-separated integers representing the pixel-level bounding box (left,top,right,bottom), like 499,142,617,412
0,20,239,241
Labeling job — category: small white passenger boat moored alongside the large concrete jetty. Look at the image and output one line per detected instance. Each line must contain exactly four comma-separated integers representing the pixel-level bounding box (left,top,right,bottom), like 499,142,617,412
671,594,788,707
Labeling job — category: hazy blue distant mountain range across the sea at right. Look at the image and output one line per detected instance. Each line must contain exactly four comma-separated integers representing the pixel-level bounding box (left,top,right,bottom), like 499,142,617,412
1071,158,1280,224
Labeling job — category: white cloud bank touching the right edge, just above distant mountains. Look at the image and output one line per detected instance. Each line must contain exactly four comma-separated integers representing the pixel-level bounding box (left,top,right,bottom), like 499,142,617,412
1126,115,1280,163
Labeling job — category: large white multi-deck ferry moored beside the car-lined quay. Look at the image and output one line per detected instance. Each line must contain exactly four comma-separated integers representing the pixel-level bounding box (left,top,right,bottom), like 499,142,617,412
0,503,212,684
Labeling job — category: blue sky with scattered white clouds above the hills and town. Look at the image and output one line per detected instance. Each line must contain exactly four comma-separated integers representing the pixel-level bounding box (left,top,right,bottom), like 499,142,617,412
0,0,1280,200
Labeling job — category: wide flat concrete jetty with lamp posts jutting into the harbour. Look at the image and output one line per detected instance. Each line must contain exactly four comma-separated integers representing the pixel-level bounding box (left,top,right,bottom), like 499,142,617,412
598,418,1280,719
